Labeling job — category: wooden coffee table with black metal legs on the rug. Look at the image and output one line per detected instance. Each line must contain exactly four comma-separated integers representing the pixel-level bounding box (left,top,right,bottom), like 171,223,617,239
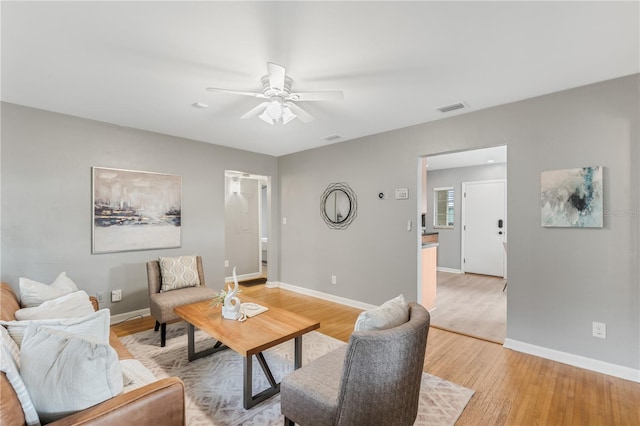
174,296,320,409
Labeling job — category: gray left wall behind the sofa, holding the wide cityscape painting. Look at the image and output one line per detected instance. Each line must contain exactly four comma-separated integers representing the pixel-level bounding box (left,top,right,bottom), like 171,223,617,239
1,103,278,314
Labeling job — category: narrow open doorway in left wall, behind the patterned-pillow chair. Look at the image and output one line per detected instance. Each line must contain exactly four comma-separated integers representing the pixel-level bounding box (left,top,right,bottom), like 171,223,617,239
225,170,270,282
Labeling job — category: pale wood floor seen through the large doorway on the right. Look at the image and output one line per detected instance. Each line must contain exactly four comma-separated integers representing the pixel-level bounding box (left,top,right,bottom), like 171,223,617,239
431,271,508,343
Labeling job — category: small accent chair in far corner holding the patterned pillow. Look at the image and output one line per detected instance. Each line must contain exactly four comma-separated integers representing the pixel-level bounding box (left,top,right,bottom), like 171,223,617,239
147,256,216,347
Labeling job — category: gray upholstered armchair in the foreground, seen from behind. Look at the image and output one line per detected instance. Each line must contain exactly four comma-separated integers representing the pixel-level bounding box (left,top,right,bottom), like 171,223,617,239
280,303,430,426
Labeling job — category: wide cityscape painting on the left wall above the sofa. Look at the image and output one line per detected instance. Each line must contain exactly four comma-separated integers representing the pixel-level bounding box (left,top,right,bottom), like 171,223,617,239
92,167,182,253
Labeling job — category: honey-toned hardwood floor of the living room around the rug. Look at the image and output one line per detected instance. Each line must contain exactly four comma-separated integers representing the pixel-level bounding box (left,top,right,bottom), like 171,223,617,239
113,285,640,426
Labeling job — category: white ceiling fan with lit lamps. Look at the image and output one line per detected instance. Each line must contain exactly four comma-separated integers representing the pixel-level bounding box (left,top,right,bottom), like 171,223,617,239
207,62,344,125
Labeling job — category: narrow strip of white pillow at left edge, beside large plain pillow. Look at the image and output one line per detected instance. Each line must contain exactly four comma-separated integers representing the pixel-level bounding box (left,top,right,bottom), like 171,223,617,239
0,326,40,426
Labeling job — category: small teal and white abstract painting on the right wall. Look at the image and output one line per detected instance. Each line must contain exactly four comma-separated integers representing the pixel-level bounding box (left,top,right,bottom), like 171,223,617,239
540,166,603,228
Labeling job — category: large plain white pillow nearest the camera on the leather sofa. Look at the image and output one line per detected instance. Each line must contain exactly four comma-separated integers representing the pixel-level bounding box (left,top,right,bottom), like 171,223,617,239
20,324,123,423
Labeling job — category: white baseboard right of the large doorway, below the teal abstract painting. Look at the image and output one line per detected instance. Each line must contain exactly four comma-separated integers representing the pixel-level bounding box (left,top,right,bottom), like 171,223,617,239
504,338,640,382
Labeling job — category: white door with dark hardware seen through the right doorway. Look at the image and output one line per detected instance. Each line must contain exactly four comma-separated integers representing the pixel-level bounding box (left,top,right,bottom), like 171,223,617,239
462,180,507,277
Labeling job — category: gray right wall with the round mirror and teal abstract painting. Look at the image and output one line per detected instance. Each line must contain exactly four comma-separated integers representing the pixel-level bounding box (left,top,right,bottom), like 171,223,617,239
278,75,640,369
